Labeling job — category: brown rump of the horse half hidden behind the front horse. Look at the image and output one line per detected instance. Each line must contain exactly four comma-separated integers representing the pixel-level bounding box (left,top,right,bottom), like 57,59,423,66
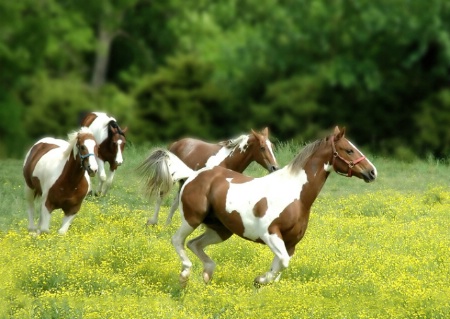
169,137,221,170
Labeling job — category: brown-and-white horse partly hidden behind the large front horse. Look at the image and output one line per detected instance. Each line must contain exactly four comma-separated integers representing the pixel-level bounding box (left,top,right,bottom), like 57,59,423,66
142,127,278,225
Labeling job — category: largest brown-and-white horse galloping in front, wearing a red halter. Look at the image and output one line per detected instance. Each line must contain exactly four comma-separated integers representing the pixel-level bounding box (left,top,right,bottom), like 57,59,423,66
140,127,377,286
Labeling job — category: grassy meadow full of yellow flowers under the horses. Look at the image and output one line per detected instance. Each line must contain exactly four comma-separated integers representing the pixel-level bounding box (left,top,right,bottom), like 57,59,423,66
0,143,450,319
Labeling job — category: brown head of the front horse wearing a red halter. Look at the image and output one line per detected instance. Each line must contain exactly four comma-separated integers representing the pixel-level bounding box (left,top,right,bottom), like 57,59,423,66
330,126,377,183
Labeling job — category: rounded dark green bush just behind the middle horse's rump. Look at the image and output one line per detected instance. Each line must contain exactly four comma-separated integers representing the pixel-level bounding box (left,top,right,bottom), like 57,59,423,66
134,56,227,141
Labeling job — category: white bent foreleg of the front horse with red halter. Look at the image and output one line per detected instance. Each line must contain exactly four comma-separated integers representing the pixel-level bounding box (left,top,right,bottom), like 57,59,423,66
254,233,291,285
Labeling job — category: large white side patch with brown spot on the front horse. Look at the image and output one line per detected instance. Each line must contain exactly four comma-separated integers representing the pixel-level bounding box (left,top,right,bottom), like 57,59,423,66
225,167,308,240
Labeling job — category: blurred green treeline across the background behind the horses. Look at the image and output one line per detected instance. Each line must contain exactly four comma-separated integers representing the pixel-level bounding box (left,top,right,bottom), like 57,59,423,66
0,0,450,159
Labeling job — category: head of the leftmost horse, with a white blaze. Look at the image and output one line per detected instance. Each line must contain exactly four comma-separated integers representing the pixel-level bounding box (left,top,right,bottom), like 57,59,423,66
75,128,98,177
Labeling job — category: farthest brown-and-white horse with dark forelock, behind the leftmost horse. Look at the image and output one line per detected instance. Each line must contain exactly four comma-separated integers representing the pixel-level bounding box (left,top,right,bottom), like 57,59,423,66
81,112,127,196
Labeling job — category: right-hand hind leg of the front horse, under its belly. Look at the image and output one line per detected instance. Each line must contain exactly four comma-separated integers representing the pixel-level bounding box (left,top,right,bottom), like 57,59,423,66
187,227,233,283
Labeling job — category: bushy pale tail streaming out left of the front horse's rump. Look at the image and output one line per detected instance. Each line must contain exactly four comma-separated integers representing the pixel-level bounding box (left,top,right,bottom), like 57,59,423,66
137,148,194,198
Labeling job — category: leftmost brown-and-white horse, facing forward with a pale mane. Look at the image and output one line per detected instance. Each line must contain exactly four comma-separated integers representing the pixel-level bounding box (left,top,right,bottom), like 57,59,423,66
23,127,98,234
